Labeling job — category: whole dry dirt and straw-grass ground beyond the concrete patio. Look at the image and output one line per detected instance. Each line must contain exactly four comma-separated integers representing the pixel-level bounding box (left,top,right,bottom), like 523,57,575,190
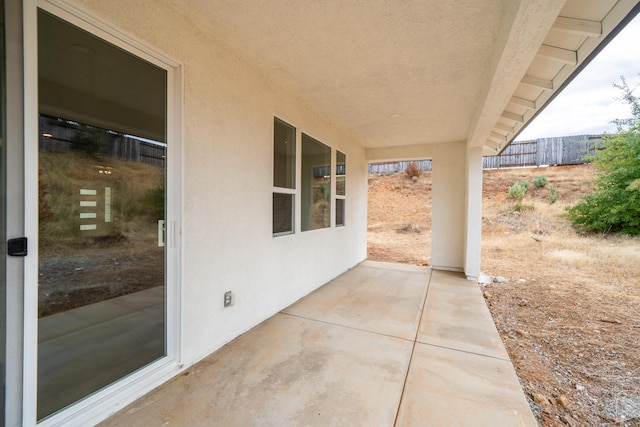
368,165,640,426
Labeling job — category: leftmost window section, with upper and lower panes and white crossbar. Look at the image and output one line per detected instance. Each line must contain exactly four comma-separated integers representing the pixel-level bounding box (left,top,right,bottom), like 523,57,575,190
272,118,296,236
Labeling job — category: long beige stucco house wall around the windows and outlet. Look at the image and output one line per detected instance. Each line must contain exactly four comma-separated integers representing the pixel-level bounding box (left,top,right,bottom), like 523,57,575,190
70,0,367,365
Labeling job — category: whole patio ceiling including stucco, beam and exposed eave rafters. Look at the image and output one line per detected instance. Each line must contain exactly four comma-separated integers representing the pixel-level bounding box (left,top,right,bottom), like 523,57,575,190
161,0,639,155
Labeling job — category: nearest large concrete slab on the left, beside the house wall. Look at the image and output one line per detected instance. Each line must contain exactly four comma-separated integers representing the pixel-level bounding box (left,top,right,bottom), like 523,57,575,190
98,314,412,426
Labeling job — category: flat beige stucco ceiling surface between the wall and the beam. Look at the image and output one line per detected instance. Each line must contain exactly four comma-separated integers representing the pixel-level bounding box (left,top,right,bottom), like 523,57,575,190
155,0,510,147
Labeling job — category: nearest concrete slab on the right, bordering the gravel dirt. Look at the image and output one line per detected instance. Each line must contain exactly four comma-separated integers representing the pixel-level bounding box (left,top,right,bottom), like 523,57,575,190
397,343,538,427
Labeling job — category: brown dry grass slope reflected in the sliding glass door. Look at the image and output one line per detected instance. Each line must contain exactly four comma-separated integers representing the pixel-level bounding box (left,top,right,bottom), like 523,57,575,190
39,152,164,255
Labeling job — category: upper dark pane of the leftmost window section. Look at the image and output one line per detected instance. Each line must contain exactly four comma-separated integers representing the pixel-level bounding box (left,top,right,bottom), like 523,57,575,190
273,119,296,188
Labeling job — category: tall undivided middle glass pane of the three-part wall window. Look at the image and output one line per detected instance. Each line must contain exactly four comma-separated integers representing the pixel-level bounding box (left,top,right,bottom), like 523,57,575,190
301,134,331,231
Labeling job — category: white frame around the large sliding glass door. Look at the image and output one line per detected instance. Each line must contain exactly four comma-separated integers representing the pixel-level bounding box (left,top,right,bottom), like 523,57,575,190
22,0,183,426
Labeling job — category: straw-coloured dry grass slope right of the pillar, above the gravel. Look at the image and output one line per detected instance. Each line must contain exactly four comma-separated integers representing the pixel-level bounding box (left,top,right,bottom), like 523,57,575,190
482,166,640,300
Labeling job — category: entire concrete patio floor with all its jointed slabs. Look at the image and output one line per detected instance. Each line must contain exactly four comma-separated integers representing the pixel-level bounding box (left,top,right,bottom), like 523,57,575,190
101,262,537,427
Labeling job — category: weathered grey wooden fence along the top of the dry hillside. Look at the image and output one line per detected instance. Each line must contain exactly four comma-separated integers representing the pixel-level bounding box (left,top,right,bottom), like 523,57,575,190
369,135,604,175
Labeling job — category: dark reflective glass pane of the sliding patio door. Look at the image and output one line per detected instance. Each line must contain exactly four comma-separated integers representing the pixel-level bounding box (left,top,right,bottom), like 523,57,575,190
37,11,167,419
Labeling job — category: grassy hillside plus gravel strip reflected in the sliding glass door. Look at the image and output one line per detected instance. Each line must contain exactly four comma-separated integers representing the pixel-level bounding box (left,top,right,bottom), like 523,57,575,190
38,152,164,317
